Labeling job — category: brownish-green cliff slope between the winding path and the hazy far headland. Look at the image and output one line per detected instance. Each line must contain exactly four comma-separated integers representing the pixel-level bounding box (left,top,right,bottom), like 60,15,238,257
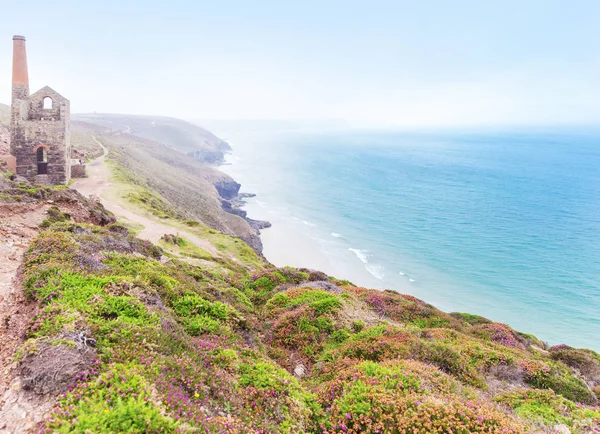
72,117,262,252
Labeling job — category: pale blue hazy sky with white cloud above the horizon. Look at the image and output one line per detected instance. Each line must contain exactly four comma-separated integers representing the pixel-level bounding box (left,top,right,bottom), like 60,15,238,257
0,0,600,125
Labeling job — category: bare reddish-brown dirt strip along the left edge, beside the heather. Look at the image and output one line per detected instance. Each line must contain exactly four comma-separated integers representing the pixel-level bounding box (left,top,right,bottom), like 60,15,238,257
0,203,52,434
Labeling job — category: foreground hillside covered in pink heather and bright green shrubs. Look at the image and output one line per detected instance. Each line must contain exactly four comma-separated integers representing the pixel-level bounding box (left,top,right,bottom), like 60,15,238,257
12,219,600,433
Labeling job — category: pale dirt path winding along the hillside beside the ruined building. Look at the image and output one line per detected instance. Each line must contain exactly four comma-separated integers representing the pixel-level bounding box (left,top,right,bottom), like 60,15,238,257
71,137,220,256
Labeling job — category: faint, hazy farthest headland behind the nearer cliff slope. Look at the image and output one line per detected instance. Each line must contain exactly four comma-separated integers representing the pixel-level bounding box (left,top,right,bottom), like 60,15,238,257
73,113,231,163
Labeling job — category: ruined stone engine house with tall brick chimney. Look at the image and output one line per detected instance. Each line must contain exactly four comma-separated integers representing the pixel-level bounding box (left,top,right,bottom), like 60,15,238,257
10,36,71,185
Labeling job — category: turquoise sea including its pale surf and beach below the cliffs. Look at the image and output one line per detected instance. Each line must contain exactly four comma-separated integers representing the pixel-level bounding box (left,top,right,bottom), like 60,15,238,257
211,123,600,350
